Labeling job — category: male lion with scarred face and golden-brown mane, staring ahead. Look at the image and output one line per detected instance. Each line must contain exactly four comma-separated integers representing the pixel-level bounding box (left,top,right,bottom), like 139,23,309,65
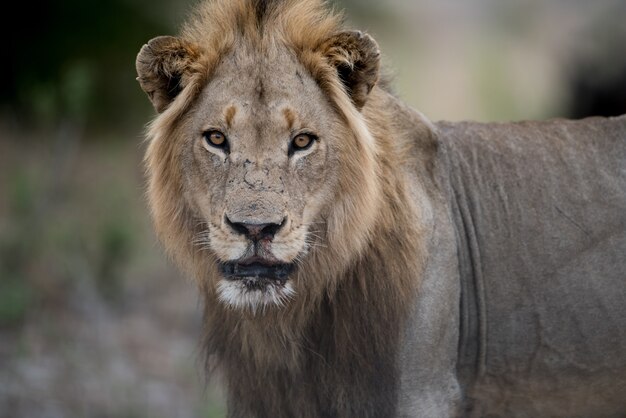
137,0,626,418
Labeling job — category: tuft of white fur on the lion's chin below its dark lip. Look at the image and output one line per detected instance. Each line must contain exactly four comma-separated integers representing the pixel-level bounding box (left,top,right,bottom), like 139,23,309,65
217,279,296,313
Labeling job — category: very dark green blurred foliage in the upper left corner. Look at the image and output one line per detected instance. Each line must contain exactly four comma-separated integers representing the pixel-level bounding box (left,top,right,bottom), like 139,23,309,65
0,0,193,130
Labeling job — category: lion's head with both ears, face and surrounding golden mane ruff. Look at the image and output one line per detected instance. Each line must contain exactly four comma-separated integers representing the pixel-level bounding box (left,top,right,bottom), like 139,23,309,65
137,0,381,310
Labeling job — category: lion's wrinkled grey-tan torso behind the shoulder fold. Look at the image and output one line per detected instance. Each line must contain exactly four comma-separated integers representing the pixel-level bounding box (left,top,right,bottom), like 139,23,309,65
437,117,626,416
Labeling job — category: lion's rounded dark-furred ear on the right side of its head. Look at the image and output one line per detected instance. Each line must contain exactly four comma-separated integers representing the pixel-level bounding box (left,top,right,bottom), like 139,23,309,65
322,31,380,109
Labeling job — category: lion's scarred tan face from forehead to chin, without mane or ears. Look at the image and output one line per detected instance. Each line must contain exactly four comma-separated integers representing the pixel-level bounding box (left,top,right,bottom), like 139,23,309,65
180,49,344,306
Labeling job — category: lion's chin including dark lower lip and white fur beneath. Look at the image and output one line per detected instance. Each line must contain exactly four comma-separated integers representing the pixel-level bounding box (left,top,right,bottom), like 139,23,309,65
217,263,295,313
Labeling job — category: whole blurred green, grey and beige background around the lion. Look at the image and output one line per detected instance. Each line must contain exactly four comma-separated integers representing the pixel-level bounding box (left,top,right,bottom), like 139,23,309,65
0,0,626,418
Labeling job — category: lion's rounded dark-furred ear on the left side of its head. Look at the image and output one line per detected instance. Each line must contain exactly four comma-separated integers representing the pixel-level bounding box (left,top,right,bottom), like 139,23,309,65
135,36,197,113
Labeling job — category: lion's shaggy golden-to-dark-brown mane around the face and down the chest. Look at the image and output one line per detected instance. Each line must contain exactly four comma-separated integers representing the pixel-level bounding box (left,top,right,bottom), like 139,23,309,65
141,0,434,417
